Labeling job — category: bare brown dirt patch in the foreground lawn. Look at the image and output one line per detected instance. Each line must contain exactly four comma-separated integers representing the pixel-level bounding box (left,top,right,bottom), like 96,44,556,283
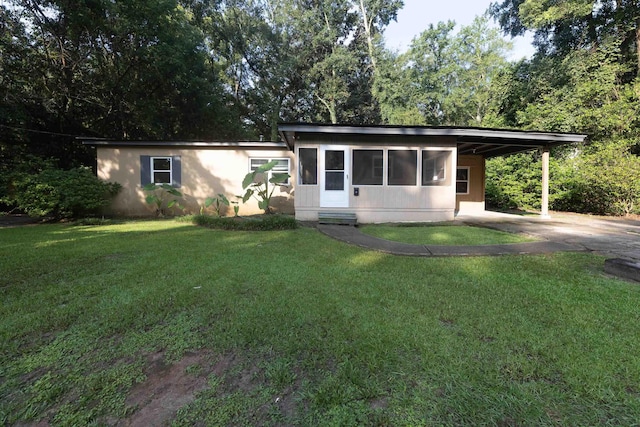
125,352,211,426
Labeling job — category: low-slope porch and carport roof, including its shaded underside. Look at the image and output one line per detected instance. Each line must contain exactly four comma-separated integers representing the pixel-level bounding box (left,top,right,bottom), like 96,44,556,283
278,123,587,158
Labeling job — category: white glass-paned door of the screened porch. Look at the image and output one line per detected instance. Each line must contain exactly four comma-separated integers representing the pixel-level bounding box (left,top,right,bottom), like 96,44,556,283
320,145,350,208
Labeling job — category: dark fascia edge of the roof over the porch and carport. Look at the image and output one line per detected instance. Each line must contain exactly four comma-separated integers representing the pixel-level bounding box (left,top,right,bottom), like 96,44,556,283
278,123,587,148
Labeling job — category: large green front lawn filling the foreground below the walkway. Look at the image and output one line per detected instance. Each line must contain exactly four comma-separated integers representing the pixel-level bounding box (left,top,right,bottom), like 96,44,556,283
0,221,640,426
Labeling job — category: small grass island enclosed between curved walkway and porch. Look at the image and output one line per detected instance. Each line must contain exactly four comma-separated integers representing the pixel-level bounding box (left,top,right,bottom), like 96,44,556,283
360,224,535,245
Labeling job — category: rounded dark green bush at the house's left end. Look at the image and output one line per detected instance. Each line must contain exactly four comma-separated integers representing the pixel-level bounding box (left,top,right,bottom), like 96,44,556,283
14,168,121,218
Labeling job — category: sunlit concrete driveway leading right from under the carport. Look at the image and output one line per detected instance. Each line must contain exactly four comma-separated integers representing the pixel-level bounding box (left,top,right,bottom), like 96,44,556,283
456,211,640,262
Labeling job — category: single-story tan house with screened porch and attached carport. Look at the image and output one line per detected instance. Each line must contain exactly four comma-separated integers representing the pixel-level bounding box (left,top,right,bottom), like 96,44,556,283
84,123,586,223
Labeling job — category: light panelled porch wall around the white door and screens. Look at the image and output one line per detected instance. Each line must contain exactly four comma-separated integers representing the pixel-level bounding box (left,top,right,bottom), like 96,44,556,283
295,136,457,223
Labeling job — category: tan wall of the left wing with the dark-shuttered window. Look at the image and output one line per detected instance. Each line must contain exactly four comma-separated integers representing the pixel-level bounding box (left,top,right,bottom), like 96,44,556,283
97,146,296,216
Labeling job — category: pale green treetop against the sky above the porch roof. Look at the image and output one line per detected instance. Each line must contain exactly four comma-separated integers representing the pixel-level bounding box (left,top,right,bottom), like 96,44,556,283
375,17,511,126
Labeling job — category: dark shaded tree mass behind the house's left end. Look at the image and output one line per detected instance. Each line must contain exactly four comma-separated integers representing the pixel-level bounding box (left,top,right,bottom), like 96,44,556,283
0,0,232,166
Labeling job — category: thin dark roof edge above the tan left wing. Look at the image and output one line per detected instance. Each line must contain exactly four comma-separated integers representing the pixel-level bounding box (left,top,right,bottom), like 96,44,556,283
82,139,289,150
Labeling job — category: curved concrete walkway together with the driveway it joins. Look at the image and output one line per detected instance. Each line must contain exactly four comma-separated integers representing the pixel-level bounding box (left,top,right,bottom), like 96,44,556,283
318,212,640,261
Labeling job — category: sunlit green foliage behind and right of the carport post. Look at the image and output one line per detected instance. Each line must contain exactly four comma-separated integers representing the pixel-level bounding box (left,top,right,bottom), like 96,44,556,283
486,28,640,215
